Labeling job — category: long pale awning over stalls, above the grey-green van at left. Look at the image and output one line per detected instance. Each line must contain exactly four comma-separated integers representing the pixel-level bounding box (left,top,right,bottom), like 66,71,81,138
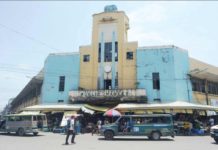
23,104,83,112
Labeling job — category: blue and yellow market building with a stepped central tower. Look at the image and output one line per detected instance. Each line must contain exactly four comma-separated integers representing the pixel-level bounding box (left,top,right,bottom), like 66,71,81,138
8,5,218,115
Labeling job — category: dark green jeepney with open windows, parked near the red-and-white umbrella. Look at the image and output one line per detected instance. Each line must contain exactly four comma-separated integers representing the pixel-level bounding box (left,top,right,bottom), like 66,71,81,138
100,114,174,140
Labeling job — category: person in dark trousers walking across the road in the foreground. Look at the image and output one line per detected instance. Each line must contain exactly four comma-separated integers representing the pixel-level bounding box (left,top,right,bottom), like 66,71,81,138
65,116,76,145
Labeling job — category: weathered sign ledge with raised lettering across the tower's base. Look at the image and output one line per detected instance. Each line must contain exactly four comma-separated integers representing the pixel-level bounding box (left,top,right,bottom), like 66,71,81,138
69,89,146,101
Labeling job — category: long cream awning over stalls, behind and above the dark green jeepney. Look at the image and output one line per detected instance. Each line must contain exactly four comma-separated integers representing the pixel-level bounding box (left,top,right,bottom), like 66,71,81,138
115,101,217,111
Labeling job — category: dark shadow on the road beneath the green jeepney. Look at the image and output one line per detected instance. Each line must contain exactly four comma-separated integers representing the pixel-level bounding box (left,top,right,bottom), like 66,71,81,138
98,138,174,142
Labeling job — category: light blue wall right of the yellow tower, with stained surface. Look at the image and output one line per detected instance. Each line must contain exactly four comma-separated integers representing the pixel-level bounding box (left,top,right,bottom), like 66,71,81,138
136,46,192,103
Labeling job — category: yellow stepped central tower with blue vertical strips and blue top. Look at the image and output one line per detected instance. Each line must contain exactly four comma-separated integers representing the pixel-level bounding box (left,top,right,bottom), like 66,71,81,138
80,5,138,90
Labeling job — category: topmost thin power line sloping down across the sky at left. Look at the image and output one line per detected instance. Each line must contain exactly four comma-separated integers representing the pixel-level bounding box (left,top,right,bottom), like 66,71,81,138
0,23,59,51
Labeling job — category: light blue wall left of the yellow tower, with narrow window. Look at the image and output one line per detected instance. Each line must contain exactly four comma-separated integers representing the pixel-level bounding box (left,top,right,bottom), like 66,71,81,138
41,53,80,104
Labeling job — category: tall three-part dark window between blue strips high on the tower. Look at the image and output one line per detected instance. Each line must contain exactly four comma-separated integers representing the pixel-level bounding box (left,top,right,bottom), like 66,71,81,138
98,42,118,62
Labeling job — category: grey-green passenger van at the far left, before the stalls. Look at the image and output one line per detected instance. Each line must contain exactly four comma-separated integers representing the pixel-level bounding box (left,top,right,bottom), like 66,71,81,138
0,113,47,136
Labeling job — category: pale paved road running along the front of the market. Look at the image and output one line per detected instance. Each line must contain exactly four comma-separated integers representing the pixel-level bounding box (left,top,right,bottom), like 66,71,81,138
0,132,218,150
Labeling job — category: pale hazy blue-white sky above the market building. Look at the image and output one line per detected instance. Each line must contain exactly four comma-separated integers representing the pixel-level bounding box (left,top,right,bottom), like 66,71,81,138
0,1,218,110
